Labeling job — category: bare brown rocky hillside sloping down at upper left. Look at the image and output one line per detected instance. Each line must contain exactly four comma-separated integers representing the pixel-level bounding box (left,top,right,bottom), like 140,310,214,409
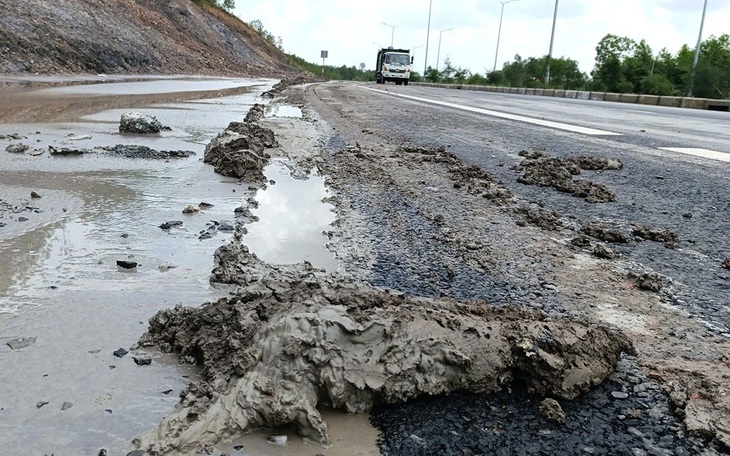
0,0,296,77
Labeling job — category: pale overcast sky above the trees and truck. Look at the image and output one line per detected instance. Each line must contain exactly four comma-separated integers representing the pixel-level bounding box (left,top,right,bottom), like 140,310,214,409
234,0,730,74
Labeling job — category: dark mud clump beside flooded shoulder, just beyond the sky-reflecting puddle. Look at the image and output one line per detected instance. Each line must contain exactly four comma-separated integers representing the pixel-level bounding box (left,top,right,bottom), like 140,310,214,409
203,104,278,182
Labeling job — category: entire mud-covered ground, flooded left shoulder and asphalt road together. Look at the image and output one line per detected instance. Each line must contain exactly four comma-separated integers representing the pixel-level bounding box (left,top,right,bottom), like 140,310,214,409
0,80,730,456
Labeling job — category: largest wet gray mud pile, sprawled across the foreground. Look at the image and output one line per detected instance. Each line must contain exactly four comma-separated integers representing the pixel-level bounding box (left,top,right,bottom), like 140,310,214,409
135,240,633,454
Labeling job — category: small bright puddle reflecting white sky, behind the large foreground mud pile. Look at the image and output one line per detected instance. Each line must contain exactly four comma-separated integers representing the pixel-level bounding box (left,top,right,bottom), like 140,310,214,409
244,161,338,271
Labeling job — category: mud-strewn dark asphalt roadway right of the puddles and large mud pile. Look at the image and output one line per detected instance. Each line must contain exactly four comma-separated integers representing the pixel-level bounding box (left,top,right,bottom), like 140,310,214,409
307,84,730,454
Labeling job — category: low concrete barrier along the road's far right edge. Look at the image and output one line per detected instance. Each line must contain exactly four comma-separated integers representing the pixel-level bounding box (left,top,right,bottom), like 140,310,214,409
411,82,730,112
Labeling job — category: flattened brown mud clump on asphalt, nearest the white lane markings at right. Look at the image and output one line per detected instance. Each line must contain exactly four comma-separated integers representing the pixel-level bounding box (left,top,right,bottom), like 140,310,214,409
517,151,623,203
